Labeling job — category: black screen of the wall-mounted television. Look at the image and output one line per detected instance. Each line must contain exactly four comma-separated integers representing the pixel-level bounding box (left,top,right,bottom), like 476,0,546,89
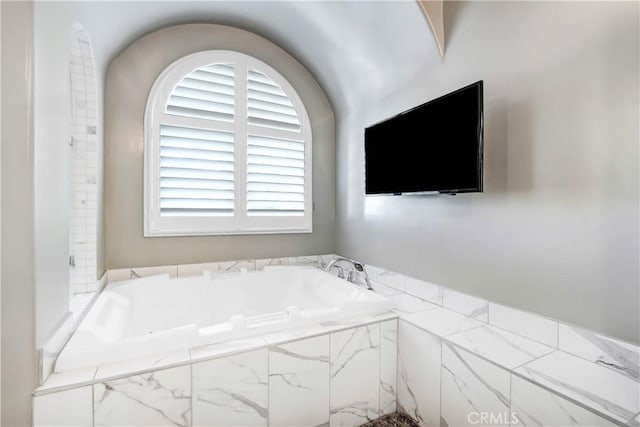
364,81,483,194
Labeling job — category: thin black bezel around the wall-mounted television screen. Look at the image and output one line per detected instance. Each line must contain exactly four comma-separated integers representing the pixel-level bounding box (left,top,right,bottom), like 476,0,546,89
363,80,484,196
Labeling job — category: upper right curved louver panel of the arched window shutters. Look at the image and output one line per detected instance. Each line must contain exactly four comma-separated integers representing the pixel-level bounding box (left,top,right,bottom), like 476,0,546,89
247,69,302,132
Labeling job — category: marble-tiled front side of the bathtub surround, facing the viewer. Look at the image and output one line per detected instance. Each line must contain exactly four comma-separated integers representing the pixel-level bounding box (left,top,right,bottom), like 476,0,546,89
34,313,397,427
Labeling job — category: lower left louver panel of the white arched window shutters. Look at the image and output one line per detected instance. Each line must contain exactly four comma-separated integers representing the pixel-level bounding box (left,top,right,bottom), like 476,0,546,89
160,125,234,217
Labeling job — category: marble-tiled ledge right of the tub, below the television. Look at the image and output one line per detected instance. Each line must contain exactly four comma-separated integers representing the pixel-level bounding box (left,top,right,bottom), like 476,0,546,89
367,266,640,426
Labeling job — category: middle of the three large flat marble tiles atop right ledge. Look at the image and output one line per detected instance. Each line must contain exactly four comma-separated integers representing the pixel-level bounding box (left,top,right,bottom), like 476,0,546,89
446,326,555,369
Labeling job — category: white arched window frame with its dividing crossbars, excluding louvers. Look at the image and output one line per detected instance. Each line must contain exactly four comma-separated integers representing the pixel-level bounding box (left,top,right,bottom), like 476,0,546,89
143,50,313,237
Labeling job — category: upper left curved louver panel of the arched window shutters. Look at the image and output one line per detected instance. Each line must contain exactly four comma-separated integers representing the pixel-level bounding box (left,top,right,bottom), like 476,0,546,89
166,64,235,122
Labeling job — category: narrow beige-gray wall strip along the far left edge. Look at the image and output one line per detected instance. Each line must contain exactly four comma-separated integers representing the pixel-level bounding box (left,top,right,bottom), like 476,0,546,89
0,2,37,427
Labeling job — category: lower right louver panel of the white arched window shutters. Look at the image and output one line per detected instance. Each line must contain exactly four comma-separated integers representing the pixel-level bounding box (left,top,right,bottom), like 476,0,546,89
247,135,305,216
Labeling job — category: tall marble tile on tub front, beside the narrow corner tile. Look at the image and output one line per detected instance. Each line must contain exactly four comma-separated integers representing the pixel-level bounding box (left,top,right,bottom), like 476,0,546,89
329,324,380,426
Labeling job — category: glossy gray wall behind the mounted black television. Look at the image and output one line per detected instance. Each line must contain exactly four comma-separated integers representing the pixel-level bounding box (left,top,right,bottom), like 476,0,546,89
336,2,640,342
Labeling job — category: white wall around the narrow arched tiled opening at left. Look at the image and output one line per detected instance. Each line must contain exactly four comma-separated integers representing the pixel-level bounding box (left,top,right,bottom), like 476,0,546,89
34,2,106,347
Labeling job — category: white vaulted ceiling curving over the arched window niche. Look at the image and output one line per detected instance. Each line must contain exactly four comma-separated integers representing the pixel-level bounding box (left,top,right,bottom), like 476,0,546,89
70,1,440,114
